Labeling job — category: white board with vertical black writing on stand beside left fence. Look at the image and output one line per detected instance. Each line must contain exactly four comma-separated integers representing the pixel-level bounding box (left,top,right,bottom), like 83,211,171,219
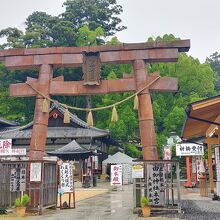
60,163,73,193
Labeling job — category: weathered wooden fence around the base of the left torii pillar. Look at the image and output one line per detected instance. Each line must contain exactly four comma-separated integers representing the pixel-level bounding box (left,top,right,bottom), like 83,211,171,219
0,161,58,210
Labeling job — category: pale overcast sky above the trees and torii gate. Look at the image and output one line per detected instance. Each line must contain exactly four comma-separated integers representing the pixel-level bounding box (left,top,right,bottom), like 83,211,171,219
0,0,220,62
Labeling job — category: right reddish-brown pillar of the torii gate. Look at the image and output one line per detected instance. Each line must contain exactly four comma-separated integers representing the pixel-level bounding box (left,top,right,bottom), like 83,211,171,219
133,60,158,160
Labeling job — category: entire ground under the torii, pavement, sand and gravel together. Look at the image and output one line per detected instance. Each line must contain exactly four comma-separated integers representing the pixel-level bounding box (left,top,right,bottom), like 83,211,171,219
0,183,217,220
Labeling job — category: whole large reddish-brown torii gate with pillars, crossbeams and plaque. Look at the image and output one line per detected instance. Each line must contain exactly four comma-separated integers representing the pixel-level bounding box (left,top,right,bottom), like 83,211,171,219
0,40,190,160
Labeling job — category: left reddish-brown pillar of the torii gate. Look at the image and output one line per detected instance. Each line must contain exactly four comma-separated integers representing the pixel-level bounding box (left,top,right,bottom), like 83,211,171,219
29,64,52,160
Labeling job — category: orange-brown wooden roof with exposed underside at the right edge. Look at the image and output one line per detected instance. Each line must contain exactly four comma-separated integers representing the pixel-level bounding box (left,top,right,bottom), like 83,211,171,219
182,95,220,140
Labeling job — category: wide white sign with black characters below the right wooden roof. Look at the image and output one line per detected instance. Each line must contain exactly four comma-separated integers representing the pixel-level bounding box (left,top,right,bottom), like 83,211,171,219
176,143,204,156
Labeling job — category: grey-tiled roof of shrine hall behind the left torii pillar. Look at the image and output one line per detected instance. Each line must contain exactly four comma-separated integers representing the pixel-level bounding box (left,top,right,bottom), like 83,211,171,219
0,106,118,155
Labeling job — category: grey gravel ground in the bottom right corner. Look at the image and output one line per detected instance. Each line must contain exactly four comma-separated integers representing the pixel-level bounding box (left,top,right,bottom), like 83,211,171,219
161,200,220,220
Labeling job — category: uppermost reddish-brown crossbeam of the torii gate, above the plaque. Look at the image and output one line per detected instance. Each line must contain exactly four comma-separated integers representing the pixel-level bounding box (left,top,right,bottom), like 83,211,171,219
0,40,190,69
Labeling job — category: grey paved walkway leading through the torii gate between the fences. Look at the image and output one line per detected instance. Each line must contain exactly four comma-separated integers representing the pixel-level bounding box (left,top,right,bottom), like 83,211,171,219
0,185,137,220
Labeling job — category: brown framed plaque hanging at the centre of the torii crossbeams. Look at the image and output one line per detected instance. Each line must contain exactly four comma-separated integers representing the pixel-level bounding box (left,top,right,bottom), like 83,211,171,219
82,52,101,86
